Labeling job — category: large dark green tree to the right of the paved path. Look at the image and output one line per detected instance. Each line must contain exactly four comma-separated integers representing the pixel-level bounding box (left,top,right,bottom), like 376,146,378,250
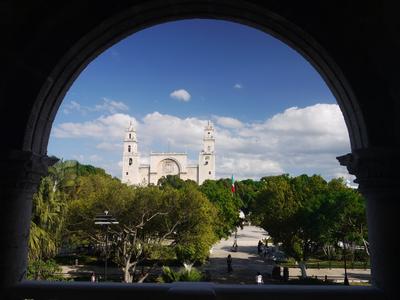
252,175,366,276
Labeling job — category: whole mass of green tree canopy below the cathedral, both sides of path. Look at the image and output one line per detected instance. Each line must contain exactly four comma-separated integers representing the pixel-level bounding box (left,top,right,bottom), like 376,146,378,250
29,161,368,282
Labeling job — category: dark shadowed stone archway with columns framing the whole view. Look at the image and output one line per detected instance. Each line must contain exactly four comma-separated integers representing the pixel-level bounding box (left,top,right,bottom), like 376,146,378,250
0,0,400,299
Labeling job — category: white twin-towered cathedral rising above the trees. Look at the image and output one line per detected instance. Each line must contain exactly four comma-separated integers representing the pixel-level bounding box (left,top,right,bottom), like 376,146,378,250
122,122,215,186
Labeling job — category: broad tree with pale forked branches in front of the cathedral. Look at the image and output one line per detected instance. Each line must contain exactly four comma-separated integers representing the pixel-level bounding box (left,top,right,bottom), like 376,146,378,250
69,175,216,282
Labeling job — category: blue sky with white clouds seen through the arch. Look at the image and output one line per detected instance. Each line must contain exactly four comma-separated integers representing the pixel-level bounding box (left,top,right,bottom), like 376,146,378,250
48,20,349,179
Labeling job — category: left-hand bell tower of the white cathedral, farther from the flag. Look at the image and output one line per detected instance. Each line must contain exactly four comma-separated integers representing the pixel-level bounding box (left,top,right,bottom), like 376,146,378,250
122,121,139,185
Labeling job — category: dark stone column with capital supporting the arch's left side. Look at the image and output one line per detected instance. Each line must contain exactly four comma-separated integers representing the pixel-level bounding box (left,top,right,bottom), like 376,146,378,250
0,150,57,288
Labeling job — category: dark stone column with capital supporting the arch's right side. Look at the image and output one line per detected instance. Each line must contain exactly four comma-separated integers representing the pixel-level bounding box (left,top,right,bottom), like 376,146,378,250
338,148,400,299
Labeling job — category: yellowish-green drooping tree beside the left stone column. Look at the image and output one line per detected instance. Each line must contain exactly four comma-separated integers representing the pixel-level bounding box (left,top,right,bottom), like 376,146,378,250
28,161,110,280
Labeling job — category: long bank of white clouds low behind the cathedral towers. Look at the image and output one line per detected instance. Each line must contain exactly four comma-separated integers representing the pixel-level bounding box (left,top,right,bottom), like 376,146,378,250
52,104,350,179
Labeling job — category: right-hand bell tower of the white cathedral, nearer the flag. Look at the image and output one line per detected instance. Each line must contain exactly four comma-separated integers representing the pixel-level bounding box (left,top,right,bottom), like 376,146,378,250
199,121,215,184
